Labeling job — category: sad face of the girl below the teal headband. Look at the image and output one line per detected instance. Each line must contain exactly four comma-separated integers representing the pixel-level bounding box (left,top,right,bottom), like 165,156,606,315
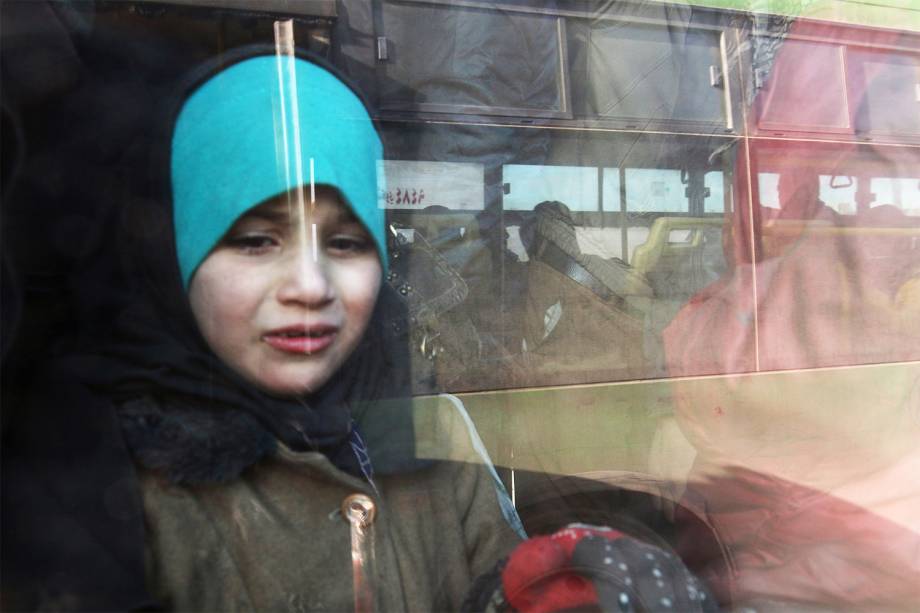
189,188,382,396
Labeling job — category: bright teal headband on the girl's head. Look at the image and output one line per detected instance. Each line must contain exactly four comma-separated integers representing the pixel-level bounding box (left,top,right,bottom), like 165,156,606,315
171,55,387,288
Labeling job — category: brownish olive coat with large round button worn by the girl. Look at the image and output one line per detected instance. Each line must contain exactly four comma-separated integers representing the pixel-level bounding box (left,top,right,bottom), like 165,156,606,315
141,397,518,611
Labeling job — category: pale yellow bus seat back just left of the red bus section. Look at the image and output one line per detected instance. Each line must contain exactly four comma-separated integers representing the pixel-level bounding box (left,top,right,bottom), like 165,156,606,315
632,217,725,299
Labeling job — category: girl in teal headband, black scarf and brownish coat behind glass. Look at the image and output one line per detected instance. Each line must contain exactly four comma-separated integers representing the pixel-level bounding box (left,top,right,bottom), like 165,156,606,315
130,50,528,610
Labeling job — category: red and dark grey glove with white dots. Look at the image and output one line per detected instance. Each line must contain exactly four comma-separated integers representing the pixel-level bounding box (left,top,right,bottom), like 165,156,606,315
502,524,719,613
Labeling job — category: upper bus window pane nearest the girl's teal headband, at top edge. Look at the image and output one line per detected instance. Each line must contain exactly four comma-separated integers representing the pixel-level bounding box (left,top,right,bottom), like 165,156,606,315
378,0,568,116
